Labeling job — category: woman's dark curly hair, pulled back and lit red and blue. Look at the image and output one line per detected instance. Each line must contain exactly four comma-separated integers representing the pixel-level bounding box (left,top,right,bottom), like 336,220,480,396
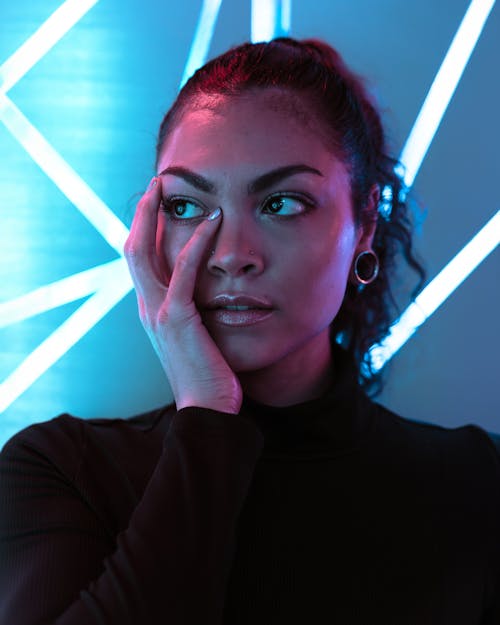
156,37,425,393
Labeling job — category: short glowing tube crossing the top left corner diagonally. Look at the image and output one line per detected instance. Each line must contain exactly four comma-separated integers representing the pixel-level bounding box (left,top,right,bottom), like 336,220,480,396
0,0,99,93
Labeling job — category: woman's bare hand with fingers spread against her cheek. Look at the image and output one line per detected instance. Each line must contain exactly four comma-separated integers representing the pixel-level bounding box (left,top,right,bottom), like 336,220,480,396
125,178,242,414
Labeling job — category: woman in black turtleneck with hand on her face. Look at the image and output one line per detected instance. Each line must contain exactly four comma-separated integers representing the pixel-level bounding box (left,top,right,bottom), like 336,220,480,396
0,39,500,625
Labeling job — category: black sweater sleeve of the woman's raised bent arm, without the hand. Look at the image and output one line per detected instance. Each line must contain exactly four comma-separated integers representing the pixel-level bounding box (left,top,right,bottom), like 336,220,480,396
0,408,262,625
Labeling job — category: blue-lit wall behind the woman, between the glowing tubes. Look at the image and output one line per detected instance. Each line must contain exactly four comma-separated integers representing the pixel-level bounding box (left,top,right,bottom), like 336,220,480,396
0,0,500,446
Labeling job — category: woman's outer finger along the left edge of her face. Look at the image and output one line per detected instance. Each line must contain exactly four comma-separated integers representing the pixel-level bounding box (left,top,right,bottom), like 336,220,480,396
124,177,165,308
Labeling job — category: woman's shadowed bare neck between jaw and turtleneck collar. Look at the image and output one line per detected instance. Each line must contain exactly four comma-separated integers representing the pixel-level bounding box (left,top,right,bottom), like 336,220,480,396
238,332,333,406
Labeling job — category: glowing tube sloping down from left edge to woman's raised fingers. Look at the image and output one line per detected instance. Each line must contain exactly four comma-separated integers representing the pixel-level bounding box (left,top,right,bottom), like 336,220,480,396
0,93,128,256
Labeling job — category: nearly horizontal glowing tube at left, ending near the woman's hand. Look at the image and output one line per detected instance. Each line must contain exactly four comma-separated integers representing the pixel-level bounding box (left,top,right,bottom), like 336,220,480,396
0,258,125,328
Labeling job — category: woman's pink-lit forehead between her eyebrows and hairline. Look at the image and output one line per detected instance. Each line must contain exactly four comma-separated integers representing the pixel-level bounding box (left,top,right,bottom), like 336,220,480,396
159,88,336,171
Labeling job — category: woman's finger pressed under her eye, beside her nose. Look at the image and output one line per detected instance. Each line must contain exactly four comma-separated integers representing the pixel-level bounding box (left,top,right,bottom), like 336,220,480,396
166,208,222,314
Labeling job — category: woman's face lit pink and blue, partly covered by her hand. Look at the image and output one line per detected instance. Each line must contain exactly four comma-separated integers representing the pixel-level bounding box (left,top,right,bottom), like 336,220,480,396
157,89,373,372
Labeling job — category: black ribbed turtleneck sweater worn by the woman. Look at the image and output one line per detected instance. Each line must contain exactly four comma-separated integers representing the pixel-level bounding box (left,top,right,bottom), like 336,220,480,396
0,354,500,625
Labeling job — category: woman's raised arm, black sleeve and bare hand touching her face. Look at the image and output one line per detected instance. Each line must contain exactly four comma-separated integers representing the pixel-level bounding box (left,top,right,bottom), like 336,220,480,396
0,178,252,625
